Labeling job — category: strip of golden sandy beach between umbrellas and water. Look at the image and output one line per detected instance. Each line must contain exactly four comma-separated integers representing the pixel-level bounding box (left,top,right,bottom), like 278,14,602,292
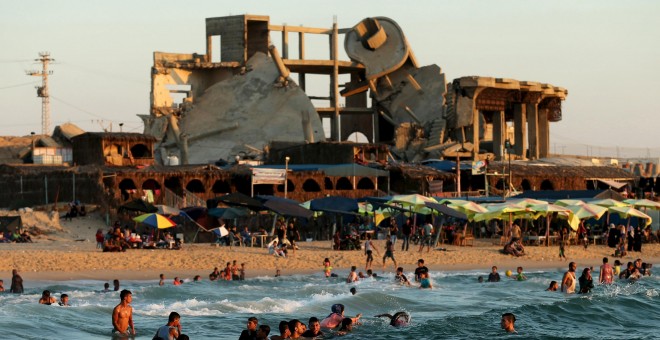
0,213,660,282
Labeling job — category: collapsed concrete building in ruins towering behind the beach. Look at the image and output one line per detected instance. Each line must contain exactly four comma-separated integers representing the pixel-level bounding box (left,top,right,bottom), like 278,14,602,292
141,15,567,164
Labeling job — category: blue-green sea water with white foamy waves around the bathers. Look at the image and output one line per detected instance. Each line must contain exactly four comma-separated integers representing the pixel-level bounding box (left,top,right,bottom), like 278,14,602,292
0,268,660,339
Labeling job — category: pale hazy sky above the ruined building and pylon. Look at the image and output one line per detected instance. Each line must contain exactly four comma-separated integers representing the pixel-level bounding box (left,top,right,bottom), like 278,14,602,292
0,0,660,157
